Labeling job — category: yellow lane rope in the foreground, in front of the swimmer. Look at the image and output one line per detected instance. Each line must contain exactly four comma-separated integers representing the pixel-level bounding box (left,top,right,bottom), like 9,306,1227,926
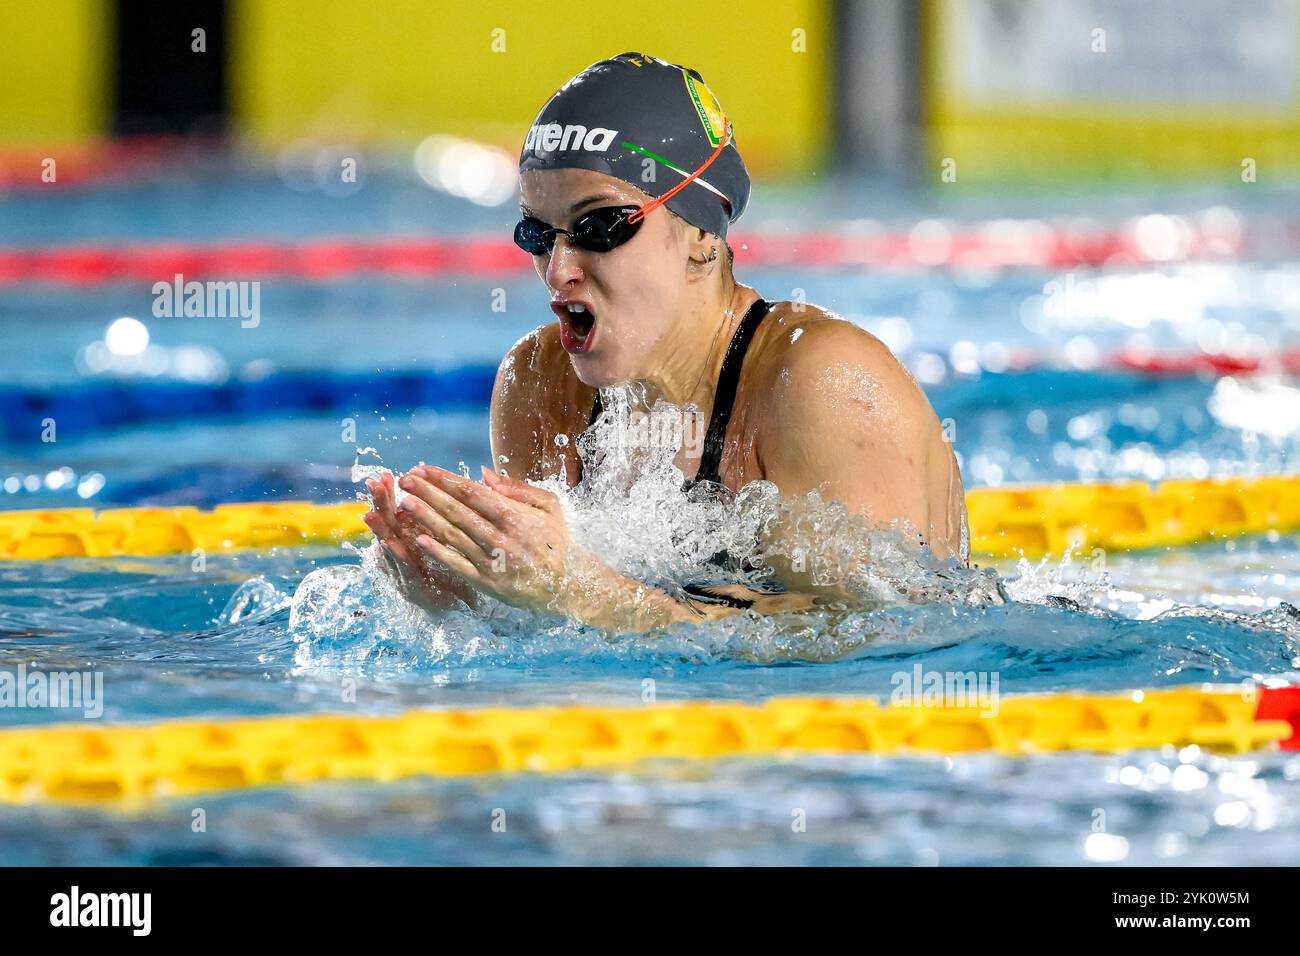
0,687,1292,804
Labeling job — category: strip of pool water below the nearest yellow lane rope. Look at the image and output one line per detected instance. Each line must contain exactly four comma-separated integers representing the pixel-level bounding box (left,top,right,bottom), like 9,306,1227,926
0,752,1300,866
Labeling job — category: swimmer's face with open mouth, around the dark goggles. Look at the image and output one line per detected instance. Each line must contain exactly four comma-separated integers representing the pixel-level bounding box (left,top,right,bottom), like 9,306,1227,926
520,169,698,388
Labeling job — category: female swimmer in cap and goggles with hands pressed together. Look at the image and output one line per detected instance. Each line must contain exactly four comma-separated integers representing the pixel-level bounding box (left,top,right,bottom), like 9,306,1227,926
365,53,967,631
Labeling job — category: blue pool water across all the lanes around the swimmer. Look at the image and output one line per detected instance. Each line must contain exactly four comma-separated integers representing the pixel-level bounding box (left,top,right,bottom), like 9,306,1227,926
0,171,1300,865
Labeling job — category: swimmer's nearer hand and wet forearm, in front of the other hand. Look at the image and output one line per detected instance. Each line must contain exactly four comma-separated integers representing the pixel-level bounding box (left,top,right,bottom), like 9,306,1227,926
398,466,732,632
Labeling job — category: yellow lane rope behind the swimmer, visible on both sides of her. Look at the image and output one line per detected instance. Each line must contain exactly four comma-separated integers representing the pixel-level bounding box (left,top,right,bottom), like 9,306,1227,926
0,475,1300,561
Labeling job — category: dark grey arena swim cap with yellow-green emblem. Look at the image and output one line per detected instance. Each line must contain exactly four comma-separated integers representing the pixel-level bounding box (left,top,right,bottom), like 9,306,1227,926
519,53,749,238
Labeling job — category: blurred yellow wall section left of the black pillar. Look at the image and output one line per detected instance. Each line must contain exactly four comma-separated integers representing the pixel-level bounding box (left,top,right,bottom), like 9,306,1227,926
0,0,111,146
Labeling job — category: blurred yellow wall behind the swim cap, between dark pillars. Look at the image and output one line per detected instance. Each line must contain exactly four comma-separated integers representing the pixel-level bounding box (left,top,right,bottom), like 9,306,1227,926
231,0,832,174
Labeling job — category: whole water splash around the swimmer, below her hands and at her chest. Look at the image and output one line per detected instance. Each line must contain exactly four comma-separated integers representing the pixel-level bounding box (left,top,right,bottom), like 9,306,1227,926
276,388,1024,667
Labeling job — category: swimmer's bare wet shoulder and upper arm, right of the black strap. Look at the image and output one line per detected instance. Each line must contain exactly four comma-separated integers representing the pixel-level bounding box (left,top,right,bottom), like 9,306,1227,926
758,323,937,594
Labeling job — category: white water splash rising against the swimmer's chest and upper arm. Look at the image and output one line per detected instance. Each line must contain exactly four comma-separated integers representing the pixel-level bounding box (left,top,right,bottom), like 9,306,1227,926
564,388,1005,606
